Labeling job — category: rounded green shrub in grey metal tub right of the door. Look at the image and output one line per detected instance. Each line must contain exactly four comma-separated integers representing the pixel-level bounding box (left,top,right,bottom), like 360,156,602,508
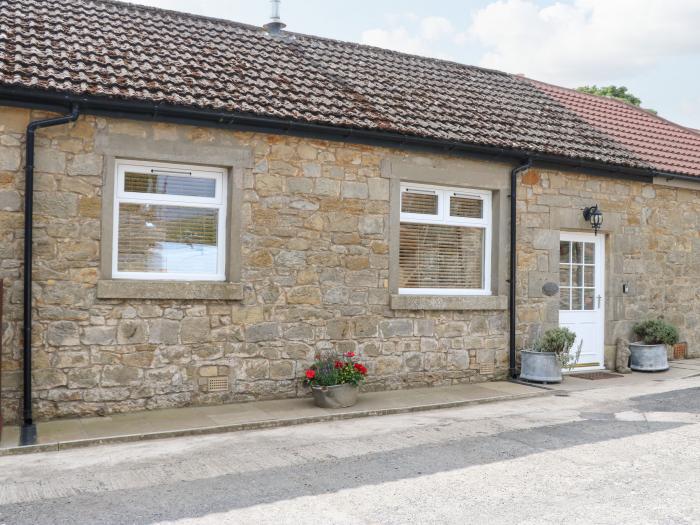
629,319,678,372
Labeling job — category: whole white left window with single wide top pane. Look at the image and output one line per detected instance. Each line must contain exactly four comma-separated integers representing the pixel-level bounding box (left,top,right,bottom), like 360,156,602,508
112,160,227,281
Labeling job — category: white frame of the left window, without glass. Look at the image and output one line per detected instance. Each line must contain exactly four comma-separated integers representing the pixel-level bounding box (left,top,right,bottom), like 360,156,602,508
111,159,228,281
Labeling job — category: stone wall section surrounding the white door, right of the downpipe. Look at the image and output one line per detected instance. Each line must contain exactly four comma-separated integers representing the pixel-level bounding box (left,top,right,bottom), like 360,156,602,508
517,169,700,367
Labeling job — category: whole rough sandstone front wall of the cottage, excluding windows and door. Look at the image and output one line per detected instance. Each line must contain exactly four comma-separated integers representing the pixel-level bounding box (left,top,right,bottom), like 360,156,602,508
0,108,700,422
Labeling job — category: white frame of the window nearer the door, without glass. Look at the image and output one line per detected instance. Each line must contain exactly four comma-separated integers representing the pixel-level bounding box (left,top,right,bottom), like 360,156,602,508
398,182,493,296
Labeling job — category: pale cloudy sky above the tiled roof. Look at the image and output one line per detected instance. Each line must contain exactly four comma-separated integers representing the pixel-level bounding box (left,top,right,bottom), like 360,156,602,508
137,0,700,128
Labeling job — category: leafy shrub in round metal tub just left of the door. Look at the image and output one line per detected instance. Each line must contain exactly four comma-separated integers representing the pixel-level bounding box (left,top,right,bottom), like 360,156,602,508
520,328,583,383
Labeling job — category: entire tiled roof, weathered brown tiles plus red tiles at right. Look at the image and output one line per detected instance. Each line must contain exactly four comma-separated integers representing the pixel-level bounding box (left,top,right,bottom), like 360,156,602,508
0,0,700,176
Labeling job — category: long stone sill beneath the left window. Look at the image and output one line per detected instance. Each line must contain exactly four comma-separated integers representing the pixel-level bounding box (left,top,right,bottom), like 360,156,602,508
97,279,243,301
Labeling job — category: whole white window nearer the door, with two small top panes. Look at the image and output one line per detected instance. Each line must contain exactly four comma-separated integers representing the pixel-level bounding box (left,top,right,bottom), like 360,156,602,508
399,183,492,295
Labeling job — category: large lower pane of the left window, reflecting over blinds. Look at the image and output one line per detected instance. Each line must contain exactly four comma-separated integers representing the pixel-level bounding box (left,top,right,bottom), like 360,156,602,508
117,203,219,274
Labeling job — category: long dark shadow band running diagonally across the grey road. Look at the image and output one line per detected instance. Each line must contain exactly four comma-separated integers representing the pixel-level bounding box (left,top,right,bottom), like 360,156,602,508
0,414,684,525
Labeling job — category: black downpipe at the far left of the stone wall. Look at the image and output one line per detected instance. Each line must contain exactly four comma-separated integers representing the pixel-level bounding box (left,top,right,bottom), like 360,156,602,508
19,104,80,446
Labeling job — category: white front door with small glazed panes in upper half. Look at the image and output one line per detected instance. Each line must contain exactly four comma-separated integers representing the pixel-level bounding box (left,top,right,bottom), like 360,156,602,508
559,232,605,370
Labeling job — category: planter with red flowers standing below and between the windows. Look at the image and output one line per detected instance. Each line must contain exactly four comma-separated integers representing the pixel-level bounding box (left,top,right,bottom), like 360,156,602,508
304,352,367,408
